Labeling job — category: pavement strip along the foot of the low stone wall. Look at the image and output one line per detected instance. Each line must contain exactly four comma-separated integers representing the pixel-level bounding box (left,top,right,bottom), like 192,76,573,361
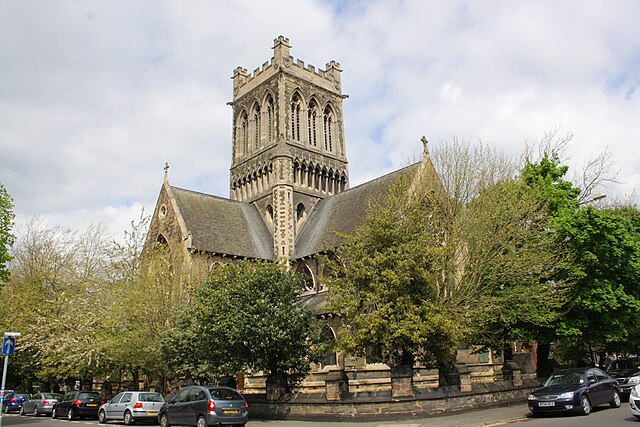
247,404,529,427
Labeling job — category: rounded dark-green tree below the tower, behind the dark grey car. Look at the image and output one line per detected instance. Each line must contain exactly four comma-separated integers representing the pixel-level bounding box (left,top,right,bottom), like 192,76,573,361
193,261,317,396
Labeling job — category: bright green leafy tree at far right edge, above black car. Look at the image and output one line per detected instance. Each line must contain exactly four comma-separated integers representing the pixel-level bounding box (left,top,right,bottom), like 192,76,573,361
558,206,640,361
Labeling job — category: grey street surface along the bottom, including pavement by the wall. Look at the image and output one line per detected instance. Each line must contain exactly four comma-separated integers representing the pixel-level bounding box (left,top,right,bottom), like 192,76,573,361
0,402,640,427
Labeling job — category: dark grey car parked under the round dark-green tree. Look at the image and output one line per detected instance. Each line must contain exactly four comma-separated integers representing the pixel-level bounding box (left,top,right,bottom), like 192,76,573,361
158,386,249,427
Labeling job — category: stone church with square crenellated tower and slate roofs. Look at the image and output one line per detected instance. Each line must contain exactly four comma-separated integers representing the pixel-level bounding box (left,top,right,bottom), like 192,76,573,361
147,36,493,392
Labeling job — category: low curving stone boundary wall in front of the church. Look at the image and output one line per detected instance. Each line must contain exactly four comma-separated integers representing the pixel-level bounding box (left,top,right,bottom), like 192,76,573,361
246,380,540,421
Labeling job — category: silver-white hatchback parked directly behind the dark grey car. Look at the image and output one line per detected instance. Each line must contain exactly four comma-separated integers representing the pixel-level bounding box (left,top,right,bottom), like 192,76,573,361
98,391,164,425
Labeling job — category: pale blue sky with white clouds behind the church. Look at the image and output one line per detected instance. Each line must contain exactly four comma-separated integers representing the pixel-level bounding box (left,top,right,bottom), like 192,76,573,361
0,0,640,241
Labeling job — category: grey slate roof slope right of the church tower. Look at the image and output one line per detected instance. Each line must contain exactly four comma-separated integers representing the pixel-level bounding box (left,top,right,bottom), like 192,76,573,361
293,163,420,258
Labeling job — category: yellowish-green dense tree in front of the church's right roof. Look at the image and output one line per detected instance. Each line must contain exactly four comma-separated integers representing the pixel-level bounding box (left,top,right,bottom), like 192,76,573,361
326,171,465,374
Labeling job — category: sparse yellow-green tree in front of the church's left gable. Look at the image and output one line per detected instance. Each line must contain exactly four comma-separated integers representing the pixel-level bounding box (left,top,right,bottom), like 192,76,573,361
98,211,189,387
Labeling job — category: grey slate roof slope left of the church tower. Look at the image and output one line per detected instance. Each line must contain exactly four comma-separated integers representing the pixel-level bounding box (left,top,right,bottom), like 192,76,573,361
171,186,275,259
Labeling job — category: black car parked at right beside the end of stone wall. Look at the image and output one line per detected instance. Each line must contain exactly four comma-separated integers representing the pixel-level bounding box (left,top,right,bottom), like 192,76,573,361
528,368,621,416
